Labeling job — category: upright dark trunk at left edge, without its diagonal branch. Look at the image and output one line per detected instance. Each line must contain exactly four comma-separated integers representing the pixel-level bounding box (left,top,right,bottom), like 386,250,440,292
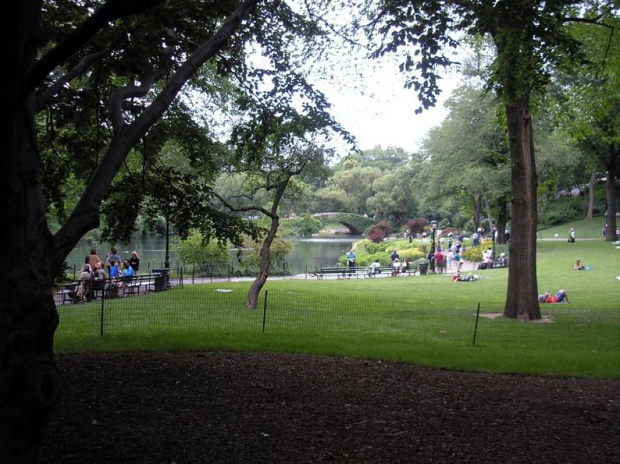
0,0,60,463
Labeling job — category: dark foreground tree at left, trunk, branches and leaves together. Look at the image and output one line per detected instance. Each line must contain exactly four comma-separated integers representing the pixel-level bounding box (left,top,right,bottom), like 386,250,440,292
0,0,344,463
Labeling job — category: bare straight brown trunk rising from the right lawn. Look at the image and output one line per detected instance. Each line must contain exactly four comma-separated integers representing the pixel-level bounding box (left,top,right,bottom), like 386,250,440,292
504,95,541,320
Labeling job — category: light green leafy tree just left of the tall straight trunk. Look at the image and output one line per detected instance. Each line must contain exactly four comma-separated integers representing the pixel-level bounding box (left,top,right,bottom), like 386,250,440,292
423,86,510,242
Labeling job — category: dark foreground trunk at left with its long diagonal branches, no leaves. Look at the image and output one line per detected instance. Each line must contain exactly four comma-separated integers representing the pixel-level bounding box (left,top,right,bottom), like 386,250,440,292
0,0,257,464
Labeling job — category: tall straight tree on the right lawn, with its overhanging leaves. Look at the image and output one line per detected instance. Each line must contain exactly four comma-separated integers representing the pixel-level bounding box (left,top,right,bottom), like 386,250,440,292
324,0,615,320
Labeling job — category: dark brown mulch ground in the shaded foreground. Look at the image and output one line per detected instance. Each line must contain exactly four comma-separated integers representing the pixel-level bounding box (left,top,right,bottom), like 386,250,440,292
42,352,620,464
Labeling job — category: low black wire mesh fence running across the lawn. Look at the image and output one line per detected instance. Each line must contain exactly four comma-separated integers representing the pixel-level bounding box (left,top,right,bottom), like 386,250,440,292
56,280,620,350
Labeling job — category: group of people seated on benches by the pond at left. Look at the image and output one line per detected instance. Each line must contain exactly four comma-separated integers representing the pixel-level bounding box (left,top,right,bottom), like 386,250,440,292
72,247,140,301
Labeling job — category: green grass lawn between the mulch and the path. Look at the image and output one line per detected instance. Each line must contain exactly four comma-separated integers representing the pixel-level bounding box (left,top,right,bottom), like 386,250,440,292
56,220,620,377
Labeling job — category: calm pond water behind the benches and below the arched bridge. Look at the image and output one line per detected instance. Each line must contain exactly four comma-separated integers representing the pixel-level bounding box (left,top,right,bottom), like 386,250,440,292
66,235,361,274
